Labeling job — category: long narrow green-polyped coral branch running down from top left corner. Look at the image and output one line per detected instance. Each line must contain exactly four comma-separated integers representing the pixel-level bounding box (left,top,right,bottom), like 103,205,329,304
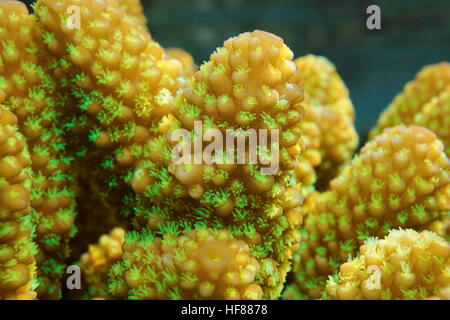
0,1,76,298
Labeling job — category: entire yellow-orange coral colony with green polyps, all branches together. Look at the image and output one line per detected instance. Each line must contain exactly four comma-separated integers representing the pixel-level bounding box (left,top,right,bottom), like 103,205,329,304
0,0,450,300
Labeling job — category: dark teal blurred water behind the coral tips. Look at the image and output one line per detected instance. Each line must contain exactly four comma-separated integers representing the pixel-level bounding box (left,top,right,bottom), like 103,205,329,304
24,0,450,140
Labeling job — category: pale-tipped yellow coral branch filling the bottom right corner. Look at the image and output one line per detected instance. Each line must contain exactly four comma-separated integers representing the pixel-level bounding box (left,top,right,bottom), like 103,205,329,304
325,229,450,300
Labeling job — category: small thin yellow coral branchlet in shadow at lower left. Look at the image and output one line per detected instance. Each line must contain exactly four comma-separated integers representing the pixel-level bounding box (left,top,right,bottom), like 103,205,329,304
80,228,125,299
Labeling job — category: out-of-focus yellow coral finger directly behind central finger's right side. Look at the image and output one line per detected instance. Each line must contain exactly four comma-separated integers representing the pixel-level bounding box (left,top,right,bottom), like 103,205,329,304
295,54,358,189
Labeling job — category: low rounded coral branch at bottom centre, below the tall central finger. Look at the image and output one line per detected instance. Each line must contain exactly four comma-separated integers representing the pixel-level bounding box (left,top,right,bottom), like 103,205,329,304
110,229,262,300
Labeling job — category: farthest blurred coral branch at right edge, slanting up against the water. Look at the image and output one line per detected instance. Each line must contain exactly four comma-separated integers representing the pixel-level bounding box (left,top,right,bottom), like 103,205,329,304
370,62,450,138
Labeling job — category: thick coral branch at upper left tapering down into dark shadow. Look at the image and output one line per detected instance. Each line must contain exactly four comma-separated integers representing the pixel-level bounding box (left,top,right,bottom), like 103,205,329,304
35,1,188,218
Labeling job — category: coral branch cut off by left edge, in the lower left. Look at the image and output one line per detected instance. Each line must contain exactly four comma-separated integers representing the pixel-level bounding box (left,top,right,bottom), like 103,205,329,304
0,107,37,300
